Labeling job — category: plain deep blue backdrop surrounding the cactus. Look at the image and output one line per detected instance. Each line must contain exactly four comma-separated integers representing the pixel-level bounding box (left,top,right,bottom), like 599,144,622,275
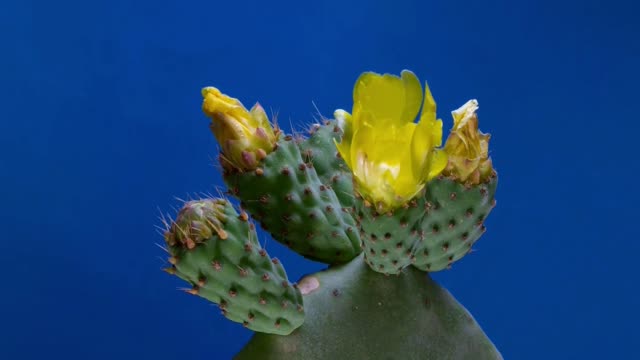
0,0,640,360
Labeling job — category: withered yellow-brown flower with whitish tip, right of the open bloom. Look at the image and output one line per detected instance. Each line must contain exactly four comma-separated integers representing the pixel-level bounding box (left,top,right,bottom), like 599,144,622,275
444,100,493,184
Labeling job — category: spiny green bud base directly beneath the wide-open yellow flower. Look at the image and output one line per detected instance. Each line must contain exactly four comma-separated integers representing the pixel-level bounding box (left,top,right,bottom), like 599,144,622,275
354,194,424,274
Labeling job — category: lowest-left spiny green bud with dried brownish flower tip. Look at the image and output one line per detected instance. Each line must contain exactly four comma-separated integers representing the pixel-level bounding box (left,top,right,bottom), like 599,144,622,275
165,199,304,335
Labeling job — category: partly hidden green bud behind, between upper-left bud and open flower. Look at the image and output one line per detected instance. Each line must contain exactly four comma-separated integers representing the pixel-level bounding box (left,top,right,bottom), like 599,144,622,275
300,120,354,207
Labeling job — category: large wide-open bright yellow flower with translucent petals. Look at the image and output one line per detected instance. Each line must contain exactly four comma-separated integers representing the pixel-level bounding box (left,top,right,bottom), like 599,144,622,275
334,70,447,212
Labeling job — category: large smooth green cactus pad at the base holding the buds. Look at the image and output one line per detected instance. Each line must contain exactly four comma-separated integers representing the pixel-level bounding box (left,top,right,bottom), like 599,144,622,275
235,256,502,360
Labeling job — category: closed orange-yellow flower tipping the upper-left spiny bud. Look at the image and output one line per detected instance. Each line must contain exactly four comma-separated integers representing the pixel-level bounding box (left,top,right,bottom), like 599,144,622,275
202,87,279,170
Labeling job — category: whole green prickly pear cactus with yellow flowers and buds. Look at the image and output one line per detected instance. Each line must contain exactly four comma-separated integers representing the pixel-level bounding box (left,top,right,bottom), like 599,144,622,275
160,70,502,360
